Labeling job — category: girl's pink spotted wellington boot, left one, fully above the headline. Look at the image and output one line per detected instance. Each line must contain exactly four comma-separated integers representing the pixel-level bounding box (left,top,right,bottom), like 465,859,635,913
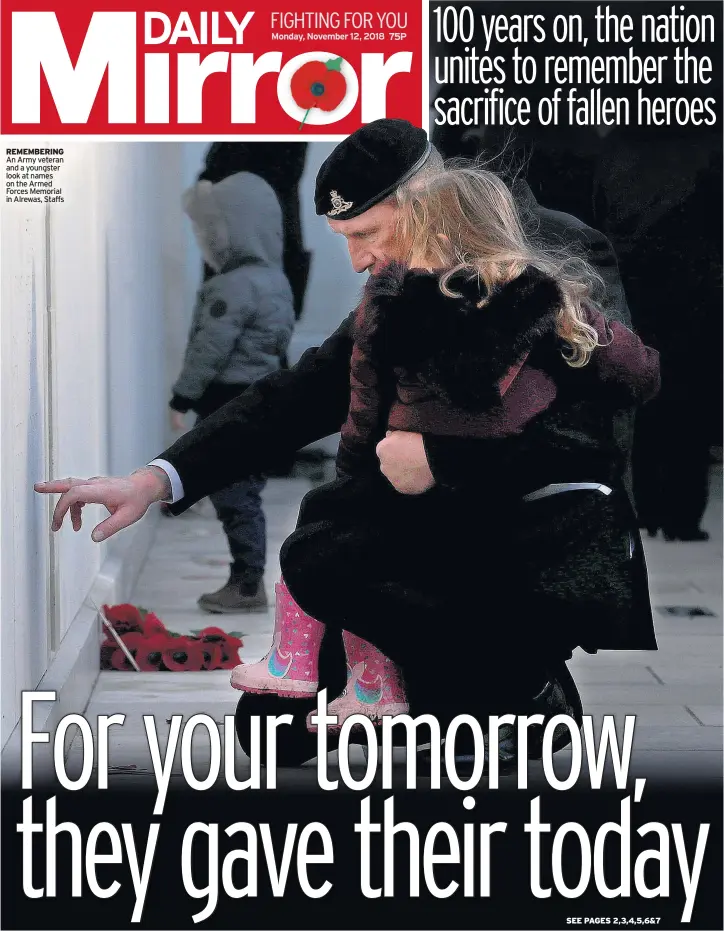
231,580,324,698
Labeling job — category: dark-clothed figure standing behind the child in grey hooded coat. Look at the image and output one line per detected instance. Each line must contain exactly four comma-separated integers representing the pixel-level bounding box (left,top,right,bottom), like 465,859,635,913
198,142,310,320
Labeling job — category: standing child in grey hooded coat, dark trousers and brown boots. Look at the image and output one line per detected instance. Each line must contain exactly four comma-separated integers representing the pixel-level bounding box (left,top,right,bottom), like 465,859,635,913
170,172,294,613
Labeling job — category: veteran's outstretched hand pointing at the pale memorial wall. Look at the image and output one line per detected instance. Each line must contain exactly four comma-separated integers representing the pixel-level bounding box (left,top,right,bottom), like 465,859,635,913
34,466,169,543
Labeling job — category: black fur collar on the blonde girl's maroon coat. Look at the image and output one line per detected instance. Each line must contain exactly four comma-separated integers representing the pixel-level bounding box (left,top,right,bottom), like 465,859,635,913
357,263,562,409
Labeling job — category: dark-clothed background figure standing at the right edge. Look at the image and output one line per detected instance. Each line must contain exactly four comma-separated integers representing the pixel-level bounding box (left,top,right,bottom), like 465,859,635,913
597,142,722,542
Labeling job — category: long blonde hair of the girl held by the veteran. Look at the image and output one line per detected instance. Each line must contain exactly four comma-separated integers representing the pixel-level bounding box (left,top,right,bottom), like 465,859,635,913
393,166,603,368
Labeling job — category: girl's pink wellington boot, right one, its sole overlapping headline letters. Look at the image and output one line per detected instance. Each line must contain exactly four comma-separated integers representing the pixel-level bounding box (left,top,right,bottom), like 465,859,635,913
307,630,410,732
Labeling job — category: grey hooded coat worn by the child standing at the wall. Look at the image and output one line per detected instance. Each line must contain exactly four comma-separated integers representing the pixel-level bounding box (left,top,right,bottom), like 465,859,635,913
172,172,294,409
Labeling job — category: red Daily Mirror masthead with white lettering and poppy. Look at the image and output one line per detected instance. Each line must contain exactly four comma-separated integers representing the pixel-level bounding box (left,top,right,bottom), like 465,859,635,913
0,0,424,139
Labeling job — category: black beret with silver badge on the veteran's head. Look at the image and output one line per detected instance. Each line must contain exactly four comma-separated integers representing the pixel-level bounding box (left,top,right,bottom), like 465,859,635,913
314,120,430,220
